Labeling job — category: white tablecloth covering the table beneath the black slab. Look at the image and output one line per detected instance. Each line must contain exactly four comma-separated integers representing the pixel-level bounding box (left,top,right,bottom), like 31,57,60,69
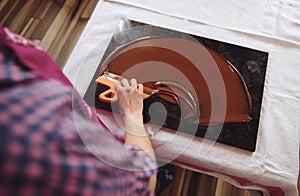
63,0,300,196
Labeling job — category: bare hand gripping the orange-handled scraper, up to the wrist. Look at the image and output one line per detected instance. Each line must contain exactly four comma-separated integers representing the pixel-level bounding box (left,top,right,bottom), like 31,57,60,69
116,79,143,124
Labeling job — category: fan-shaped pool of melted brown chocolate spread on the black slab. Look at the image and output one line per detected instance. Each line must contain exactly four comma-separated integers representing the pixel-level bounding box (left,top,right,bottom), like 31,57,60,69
103,37,252,125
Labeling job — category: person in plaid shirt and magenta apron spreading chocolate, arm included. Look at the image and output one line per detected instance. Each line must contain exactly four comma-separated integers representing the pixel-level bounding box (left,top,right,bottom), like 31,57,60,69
0,27,157,195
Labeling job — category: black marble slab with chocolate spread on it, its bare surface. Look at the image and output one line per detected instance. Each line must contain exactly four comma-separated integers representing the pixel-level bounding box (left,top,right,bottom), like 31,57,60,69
84,19,268,152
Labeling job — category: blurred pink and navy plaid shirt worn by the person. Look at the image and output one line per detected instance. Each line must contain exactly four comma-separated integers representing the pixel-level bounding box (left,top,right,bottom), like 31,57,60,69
0,44,156,195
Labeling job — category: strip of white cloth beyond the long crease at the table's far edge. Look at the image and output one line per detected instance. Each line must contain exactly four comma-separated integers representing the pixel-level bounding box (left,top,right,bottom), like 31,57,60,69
108,0,300,43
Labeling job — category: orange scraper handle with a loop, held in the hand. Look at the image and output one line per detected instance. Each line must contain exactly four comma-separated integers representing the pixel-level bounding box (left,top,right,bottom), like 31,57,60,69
96,76,150,103
